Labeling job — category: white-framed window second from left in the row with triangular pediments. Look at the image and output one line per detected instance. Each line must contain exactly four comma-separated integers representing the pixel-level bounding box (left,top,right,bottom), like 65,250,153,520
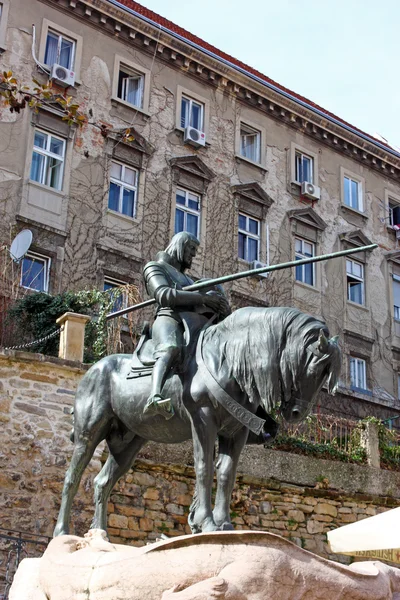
108,161,138,217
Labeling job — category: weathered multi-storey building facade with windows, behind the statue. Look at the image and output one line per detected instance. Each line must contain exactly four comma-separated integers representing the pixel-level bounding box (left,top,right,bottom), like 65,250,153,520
0,0,400,426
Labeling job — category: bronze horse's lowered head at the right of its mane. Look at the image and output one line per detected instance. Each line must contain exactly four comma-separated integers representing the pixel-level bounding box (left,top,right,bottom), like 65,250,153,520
281,329,341,423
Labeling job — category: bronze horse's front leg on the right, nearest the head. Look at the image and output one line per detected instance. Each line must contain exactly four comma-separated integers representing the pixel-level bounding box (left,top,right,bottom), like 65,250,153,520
213,427,249,529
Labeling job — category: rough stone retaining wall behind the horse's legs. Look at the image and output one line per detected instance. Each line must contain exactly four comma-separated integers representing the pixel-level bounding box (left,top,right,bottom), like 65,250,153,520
0,352,400,559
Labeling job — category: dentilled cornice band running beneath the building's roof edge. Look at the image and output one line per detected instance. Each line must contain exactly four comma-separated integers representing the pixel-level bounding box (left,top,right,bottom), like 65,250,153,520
39,0,400,183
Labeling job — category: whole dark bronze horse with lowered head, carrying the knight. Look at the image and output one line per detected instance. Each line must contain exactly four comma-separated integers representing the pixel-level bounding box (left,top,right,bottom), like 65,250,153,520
54,308,341,536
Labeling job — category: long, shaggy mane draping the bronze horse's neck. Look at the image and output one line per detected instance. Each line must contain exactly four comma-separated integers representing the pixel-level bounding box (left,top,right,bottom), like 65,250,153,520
207,307,340,412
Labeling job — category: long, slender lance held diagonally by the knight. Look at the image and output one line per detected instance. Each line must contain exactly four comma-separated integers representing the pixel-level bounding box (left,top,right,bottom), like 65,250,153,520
106,244,378,321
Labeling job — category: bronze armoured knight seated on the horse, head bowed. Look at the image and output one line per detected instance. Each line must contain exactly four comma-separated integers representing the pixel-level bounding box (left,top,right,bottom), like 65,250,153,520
143,231,231,419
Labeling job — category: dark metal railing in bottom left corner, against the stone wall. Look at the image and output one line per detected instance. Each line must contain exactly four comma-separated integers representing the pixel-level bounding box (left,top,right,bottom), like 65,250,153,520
0,528,51,600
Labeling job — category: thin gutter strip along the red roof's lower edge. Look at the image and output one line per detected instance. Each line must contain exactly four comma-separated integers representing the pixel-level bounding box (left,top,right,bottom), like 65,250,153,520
107,0,400,159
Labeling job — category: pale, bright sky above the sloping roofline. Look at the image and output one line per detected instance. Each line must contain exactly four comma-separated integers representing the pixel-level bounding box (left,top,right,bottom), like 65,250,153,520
137,0,400,146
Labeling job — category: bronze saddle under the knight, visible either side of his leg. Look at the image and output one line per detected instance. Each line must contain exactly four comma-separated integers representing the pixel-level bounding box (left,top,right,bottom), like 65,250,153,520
127,312,212,379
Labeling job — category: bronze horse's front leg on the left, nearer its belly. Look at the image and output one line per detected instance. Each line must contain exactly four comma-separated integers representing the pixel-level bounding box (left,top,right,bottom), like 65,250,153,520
189,407,217,533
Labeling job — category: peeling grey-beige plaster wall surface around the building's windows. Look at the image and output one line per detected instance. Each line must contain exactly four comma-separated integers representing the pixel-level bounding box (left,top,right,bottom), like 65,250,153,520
0,0,400,416
